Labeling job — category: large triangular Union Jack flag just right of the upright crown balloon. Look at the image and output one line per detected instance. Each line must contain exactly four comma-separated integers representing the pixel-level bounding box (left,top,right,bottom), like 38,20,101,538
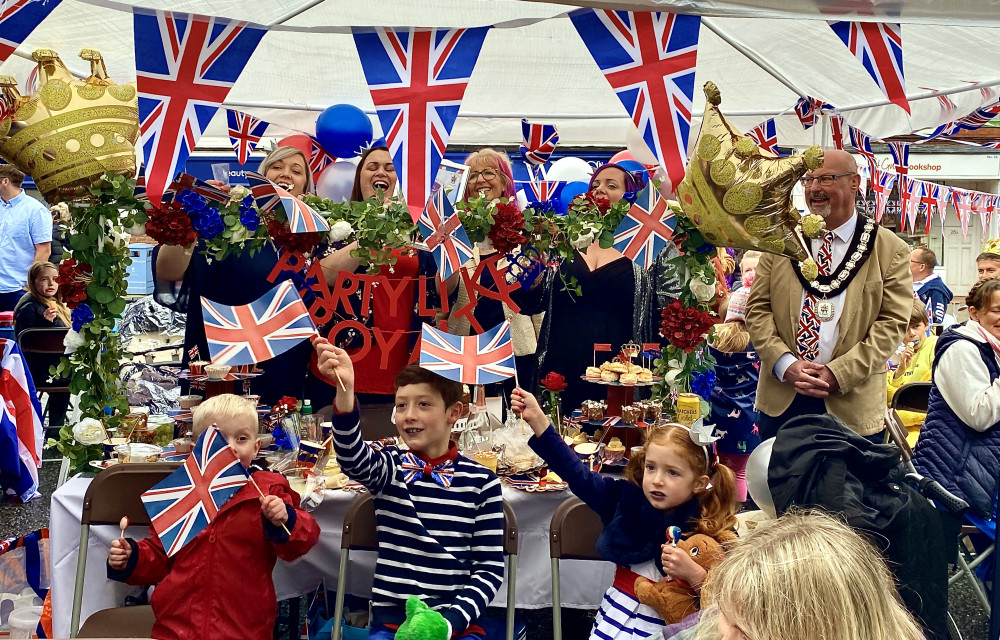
133,7,265,206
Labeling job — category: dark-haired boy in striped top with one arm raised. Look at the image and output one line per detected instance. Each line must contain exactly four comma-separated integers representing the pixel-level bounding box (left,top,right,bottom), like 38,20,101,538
316,340,503,640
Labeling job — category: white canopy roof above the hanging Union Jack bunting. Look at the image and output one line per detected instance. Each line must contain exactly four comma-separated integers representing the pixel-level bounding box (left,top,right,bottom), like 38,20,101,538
0,0,1000,152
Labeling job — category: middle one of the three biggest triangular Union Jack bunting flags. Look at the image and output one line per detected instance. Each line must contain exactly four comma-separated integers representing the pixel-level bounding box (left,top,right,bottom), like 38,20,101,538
354,27,490,218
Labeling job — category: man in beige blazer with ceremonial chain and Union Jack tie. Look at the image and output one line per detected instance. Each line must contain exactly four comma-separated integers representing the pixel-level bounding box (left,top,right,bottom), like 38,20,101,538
746,149,913,442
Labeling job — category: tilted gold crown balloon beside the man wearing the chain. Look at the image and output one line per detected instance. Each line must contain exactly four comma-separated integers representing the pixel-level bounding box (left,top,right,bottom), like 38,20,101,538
677,82,823,261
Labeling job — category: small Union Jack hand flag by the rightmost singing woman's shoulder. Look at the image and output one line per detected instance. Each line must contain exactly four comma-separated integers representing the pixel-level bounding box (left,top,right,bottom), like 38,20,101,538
615,184,677,269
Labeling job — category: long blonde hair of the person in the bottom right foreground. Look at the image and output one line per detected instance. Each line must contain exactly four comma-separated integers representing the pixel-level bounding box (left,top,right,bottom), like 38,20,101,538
697,511,924,640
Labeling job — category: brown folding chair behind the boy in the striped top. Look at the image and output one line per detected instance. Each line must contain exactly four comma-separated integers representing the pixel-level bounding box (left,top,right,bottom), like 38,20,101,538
332,493,518,640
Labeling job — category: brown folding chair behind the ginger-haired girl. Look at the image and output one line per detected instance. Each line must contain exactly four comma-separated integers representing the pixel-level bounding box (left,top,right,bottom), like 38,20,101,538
549,497,604,640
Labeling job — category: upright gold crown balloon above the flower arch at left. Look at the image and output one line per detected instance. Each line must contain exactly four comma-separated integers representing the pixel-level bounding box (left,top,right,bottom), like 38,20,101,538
0,49,139,203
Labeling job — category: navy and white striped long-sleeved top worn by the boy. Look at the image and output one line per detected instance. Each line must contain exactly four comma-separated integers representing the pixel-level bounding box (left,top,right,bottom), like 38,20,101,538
333,405,504,633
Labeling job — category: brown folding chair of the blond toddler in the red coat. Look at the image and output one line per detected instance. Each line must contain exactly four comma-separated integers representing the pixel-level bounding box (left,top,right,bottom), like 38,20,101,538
69,462,181,638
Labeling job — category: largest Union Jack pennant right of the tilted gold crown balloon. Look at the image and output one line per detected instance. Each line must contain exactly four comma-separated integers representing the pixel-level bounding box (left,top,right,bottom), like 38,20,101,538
830,21,910,113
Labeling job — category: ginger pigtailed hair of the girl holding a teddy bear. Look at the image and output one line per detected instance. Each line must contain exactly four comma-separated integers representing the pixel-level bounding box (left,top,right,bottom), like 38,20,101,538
625,423,736,539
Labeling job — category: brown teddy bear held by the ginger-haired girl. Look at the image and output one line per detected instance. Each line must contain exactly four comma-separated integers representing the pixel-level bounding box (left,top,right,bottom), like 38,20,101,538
635,532,736,624
